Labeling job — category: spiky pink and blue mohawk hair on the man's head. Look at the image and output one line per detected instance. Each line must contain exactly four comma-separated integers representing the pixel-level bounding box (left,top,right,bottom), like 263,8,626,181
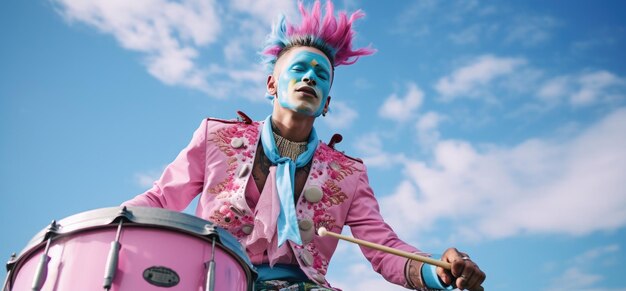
261,0,375,72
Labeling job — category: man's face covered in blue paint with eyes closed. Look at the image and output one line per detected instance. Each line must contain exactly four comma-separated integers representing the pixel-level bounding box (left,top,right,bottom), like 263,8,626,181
274,47,333,117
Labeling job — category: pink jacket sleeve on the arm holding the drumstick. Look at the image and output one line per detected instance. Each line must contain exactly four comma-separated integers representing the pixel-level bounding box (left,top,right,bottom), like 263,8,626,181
346,170,421,287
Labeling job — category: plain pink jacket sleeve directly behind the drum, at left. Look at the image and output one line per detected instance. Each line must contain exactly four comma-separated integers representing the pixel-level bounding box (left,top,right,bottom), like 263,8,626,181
122,119,208,211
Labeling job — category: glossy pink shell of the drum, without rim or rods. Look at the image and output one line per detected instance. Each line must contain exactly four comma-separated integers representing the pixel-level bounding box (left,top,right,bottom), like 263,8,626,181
10,209,251,291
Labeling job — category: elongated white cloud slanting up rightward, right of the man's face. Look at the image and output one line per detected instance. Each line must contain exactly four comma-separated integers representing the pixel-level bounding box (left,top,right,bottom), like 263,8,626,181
435,55,526,101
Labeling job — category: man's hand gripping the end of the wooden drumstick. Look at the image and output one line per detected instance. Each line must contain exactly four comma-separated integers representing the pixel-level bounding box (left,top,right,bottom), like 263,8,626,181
437,248,486,290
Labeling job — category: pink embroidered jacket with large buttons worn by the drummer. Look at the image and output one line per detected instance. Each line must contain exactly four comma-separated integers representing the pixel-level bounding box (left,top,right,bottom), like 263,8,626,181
124,118,418,287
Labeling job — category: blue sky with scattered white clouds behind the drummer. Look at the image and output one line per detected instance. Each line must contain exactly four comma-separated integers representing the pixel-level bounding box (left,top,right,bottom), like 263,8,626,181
0,0,626,291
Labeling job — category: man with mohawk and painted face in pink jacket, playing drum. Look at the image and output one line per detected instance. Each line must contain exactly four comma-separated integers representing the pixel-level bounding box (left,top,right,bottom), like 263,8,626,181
124,1,485,290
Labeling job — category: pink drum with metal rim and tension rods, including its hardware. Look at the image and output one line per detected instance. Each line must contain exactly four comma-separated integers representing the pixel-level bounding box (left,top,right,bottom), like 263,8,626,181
3,207,256,291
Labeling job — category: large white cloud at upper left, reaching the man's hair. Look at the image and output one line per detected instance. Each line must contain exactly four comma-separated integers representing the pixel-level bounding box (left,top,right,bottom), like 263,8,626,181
53,0,295,100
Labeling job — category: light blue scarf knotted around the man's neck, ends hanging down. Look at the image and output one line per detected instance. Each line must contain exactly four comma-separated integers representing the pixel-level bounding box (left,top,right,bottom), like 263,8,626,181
261,115,319,247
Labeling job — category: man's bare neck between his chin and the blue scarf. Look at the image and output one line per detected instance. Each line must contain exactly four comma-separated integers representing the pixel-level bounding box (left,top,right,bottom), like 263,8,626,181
272,110,315,142
